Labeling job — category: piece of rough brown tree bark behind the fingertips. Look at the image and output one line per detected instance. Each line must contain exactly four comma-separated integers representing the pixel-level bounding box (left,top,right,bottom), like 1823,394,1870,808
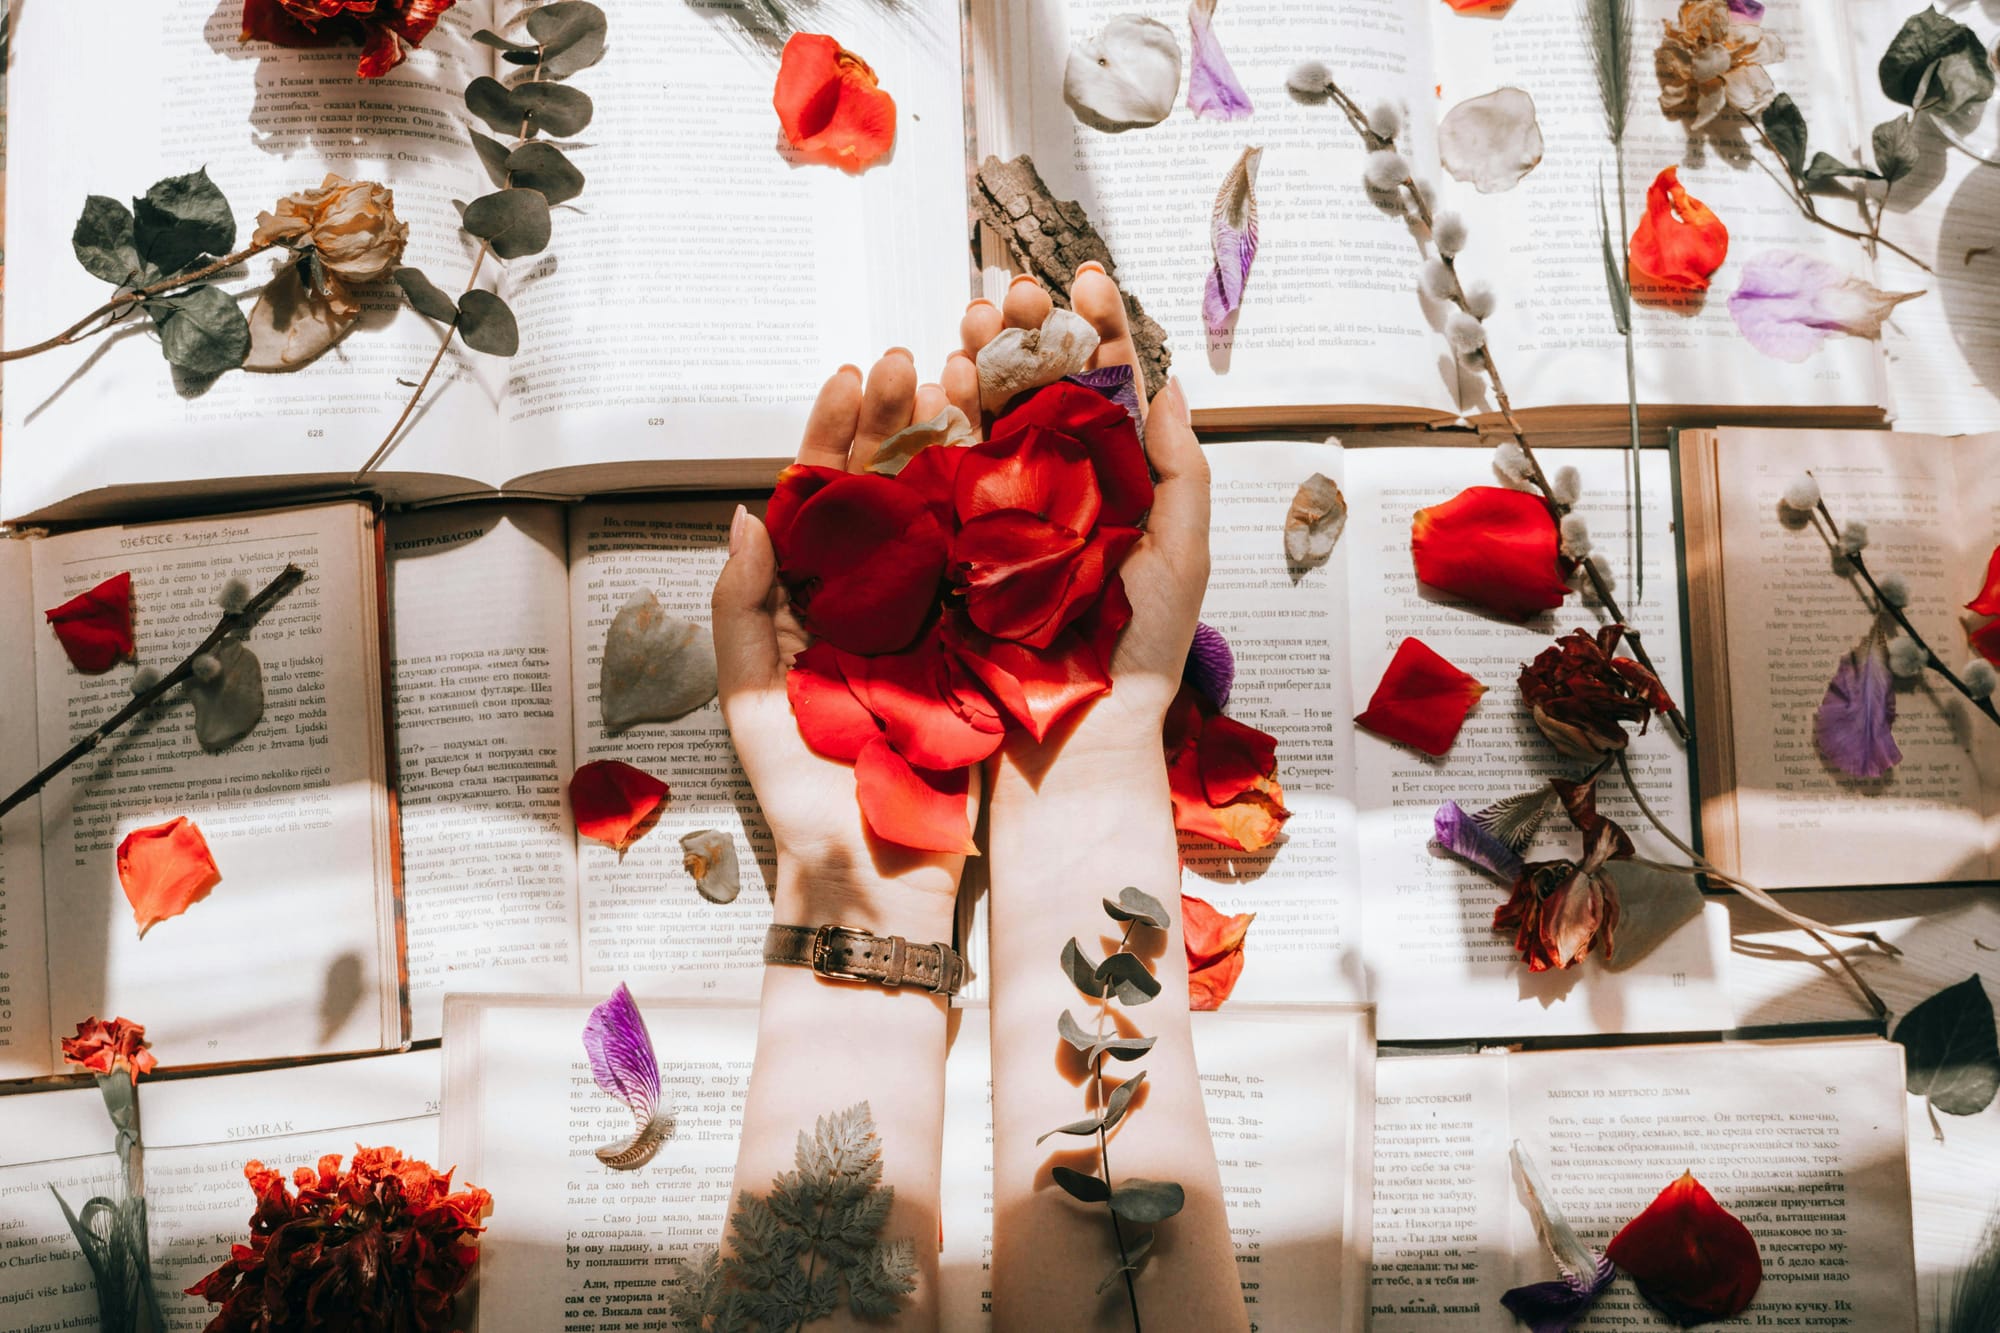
974,154,1174,392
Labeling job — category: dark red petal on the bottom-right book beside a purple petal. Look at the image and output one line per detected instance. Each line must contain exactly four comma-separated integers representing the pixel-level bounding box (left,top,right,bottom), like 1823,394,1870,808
1604,1171,1764,1323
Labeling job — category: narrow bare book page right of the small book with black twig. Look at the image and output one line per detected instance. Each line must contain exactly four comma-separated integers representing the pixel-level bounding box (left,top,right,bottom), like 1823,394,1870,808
388,504,580,1041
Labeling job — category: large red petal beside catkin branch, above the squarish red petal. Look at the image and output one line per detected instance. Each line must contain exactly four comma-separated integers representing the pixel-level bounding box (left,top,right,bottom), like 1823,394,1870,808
1410,486,1570,620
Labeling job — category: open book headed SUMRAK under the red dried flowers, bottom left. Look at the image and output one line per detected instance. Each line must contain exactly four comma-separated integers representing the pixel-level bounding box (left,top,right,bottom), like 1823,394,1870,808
0,1033,438,1333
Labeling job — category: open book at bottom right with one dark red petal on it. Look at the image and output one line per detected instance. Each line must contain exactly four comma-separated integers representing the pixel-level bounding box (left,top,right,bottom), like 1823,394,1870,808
1370,1041,1916,1333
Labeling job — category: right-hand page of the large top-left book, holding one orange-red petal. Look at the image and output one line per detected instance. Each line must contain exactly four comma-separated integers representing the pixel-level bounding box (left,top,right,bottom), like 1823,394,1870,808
500,0,972,490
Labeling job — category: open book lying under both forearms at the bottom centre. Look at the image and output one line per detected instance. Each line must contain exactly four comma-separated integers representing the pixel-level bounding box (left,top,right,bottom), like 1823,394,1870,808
440,995,1374,1333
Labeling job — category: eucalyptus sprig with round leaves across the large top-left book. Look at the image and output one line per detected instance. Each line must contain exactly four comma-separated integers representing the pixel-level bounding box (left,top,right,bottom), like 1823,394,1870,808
354,0,606,480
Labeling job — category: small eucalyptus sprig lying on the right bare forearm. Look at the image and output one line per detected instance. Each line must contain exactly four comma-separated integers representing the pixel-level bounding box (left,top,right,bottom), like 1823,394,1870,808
1036,887,1186,1333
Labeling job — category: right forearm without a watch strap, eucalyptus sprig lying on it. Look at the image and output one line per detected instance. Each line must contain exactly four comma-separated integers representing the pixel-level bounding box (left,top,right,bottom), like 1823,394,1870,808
990,747,1248,1333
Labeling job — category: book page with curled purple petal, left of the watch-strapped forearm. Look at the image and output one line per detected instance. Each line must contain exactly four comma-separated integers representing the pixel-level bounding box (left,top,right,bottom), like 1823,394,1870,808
442,997,756,1333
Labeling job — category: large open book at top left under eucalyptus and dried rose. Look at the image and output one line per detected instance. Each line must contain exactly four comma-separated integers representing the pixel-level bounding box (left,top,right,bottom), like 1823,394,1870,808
0,0,972,518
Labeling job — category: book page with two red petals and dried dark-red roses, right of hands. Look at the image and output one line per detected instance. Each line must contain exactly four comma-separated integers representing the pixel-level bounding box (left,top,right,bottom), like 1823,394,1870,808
1342,446,1730,1039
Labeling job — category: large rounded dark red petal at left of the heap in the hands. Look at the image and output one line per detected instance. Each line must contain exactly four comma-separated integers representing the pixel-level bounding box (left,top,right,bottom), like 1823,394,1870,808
770,468,946,654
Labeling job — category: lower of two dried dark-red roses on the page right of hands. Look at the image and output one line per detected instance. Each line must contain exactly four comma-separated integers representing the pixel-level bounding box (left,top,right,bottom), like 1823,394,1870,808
1494,779,1632,973
